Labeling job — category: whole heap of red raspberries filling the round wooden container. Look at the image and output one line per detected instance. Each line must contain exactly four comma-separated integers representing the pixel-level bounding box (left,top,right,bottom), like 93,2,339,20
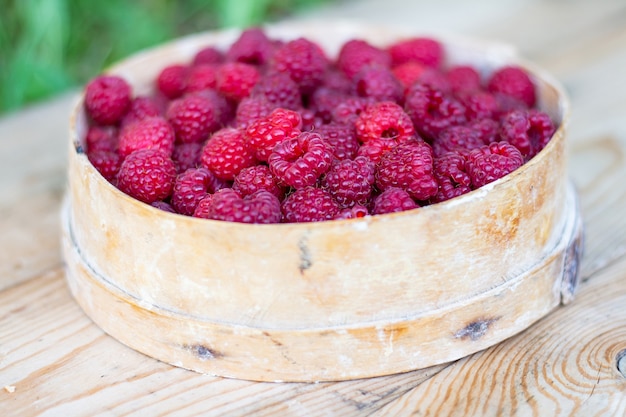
84,28,555,223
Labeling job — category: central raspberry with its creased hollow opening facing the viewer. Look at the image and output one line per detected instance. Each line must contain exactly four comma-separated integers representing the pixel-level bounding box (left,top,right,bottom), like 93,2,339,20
268,132,333,188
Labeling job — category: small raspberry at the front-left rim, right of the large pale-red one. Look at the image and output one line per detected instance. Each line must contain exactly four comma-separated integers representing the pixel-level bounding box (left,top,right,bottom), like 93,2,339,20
171,168,213,216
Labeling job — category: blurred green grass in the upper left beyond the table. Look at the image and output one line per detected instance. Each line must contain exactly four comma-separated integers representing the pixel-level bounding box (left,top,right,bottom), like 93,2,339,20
0,0,325,113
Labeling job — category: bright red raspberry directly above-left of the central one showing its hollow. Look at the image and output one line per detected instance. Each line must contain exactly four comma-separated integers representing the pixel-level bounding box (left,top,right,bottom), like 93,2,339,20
245,108,302,161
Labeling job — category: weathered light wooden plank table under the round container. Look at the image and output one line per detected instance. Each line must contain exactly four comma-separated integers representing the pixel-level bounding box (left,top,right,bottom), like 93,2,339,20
0,0,626,416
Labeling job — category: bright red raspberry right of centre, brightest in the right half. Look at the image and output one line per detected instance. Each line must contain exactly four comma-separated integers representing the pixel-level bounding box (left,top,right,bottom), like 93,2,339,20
354,101,415,143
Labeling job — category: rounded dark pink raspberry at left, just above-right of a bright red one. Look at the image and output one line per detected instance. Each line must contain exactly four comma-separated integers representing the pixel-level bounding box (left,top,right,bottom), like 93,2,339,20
166,93,220,143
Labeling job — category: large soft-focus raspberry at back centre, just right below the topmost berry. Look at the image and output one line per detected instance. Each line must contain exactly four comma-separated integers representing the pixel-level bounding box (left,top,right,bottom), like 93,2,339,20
272,38,329,94
